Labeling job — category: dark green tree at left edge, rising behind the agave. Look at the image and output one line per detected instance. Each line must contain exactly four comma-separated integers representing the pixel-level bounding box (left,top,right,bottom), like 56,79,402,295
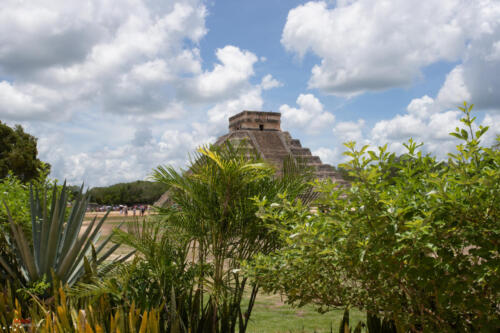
0,121,50,182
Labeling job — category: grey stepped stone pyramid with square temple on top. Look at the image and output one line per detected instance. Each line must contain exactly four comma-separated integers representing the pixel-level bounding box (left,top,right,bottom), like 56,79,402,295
216,111,346,184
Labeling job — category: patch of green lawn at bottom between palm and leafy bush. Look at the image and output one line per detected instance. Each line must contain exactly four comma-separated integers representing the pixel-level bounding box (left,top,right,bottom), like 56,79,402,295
245,294,365,333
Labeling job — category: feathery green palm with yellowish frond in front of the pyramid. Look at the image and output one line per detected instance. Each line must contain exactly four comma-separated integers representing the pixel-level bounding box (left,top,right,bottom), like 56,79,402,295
153,144,311,332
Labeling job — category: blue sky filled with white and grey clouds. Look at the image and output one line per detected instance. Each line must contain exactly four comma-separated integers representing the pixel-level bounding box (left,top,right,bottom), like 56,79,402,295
0,0,500,187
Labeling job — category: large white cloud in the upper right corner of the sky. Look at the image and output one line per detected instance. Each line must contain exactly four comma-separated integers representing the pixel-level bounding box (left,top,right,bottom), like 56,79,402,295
281,0,500,96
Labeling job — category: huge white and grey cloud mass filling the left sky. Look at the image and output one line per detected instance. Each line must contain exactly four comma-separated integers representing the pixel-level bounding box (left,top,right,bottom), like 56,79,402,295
0,0,281,186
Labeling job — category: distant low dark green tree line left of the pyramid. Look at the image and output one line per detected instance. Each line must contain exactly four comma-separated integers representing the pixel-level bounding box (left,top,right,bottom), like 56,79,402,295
90,180,167,205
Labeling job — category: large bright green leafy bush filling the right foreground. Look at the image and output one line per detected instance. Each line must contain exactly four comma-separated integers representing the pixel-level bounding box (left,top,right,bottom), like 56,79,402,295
250,102,500,332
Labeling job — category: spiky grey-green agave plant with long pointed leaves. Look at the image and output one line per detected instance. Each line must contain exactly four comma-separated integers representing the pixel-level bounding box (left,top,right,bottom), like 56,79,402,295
0,183,131,286
